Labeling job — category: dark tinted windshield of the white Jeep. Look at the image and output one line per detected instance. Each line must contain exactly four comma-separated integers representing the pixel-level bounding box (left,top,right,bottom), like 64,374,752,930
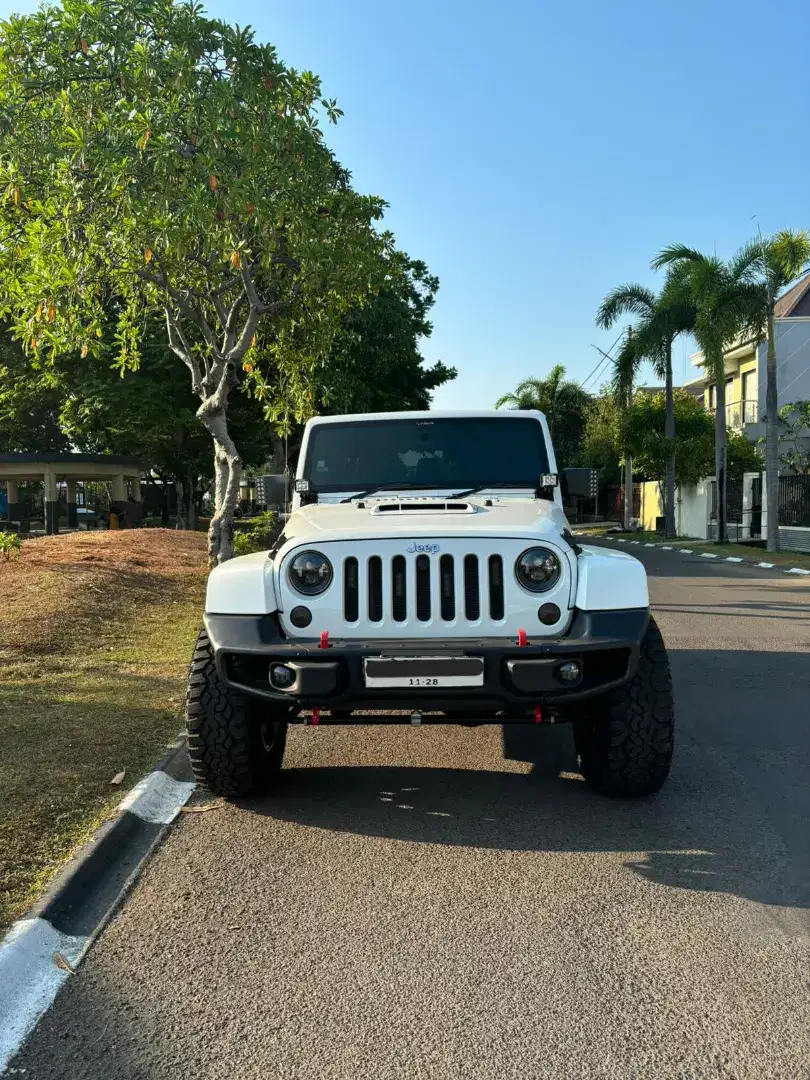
303,416,549,491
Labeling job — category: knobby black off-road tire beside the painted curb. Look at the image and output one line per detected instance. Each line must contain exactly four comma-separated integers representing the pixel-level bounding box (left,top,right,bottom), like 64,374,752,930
186,630,288,798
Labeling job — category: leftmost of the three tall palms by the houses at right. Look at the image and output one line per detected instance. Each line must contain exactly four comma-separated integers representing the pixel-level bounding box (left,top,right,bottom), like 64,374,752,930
596,266,697,537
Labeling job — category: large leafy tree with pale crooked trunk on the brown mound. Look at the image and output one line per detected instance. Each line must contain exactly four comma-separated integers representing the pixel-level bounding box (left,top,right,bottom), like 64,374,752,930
0,0,391,564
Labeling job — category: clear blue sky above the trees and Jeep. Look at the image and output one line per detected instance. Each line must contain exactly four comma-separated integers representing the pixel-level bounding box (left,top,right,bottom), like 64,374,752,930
0,0,810,408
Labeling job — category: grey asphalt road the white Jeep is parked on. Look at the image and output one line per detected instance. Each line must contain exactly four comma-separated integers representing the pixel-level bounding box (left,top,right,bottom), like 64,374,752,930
13,548,810,1080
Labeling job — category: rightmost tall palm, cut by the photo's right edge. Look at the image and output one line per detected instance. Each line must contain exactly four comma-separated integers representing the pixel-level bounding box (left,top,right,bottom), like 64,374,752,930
732,229,810,551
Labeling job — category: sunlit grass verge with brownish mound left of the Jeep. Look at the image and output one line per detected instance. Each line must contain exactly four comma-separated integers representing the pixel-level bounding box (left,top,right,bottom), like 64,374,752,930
0,529,206,931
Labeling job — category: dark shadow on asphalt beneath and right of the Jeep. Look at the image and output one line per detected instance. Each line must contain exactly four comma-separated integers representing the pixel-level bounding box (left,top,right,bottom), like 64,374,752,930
245,650,810,908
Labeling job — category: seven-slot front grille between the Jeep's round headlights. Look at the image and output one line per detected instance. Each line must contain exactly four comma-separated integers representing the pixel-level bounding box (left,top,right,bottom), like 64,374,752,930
343,554,505,623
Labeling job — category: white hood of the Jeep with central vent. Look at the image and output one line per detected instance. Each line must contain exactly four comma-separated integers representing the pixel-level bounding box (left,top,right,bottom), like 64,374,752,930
284,497,568,543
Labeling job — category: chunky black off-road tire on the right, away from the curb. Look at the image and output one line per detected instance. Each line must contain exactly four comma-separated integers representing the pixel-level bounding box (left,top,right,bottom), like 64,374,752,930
573,619,675,798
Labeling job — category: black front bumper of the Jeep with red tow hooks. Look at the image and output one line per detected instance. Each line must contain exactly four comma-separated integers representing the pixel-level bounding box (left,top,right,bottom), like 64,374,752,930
205,608,649,716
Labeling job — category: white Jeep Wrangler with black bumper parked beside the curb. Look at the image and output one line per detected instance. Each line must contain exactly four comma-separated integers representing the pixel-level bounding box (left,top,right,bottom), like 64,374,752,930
187,411,674,797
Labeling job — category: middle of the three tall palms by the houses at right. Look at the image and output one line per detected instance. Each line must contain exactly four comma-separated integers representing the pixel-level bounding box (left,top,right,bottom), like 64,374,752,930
652,244,761,543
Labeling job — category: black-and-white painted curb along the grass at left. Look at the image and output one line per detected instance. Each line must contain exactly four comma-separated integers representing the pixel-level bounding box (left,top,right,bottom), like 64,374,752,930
0,742,194,1075
